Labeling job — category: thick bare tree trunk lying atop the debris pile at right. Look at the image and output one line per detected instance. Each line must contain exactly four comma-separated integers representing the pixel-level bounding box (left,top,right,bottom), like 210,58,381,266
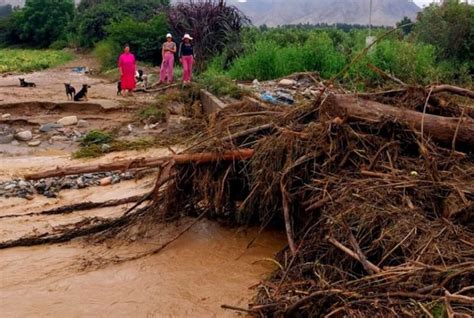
322,94,474,151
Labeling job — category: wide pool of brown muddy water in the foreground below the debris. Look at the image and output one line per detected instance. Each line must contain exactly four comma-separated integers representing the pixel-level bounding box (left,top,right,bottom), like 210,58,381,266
0,220,284,317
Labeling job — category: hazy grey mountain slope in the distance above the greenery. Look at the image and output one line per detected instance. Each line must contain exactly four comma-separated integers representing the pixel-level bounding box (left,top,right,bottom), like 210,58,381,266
229,0,420,26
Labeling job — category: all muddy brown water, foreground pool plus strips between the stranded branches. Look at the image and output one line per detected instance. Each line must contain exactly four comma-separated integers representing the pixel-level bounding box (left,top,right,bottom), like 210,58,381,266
0,149,285,317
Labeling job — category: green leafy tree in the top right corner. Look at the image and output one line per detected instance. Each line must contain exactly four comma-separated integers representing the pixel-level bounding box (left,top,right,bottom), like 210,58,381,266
415,0,474,65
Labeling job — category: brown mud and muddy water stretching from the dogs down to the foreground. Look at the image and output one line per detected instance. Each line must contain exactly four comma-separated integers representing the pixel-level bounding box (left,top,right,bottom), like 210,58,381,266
0,58,284,317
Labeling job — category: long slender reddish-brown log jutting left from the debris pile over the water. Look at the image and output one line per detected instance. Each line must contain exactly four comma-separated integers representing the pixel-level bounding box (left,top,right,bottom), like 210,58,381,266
25,149,254,180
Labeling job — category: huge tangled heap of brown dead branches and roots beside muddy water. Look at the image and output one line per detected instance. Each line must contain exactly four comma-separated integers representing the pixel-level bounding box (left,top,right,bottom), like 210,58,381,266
0,72,474,317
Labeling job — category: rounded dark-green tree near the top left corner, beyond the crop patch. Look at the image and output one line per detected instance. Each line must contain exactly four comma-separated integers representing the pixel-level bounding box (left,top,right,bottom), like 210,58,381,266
13,0,74,47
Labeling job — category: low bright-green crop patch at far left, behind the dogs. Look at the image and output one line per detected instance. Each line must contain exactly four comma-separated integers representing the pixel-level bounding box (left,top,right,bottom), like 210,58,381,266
0,49,74,73
